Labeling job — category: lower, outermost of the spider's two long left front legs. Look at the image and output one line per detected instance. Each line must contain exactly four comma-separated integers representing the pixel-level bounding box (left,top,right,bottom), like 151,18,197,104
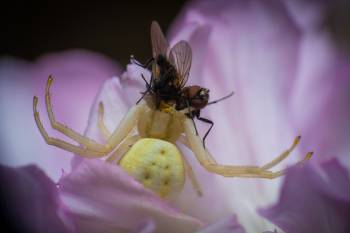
33,96,105,158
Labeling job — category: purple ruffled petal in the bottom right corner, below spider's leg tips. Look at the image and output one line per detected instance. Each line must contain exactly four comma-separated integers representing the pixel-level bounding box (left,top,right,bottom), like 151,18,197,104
260,160,350,233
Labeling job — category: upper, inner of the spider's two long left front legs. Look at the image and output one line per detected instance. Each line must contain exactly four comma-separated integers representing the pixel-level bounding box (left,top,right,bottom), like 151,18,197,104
45,76,113,153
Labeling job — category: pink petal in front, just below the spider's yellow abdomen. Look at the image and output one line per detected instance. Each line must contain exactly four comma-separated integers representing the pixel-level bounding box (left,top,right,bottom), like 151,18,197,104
60,160,202,233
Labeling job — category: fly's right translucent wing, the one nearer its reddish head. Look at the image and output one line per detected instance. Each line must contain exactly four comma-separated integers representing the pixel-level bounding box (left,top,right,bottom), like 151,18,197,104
169,40,192,88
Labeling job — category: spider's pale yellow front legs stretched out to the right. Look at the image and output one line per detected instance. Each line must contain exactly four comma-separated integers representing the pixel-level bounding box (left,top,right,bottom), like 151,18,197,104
184,119,312,179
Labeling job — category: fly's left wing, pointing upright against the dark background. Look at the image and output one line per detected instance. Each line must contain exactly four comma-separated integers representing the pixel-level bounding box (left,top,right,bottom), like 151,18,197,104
151,21,169,58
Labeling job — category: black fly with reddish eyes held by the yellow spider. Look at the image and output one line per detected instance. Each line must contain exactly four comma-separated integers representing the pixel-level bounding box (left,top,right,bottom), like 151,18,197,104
132,21,233,146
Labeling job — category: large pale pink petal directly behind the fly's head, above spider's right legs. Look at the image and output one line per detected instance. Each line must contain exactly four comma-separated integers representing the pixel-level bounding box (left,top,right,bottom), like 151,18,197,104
171,1,301,163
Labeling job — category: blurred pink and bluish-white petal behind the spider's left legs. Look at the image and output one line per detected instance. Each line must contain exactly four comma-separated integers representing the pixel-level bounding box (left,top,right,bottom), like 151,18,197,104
0,50,119,179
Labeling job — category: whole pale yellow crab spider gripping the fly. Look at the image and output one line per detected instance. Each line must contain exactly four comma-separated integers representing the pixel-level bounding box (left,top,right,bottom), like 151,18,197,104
33,76,312,197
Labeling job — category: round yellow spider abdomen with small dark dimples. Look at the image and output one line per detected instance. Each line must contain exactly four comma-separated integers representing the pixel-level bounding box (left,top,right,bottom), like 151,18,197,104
119,138,185,197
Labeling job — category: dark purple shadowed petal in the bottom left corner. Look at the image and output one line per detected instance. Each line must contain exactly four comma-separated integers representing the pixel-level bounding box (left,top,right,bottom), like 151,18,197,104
0,165,73,233
